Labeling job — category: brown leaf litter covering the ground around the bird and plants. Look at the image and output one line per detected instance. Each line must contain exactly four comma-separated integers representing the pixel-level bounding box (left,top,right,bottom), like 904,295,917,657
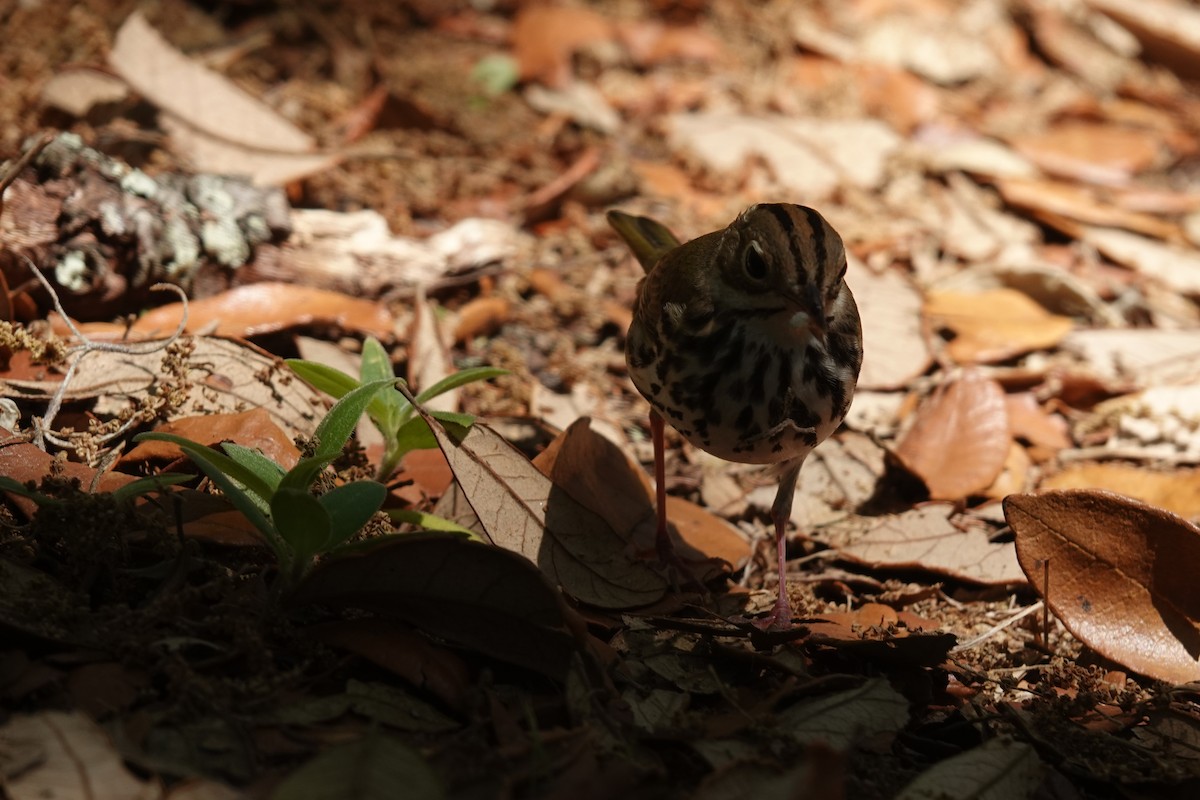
7,0,1200,798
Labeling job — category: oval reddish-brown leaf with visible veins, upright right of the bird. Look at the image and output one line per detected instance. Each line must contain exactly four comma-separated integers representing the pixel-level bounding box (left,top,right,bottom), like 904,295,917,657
895,369,1009,500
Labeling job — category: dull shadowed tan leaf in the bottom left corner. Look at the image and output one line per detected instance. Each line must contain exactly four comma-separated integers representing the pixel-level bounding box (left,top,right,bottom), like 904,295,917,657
0,711,162,800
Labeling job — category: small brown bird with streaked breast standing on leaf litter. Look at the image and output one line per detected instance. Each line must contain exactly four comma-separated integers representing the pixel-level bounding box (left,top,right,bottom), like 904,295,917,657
608,203,863,628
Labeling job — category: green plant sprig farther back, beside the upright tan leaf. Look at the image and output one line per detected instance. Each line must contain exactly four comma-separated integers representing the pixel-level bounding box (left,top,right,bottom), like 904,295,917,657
287,338,508,482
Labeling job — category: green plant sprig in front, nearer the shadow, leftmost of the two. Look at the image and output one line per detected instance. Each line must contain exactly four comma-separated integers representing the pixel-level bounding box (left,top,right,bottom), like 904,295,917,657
134,378,396,588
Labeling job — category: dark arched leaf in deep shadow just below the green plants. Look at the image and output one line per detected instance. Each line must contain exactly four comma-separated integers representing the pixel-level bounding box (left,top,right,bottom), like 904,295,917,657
292,534,576,680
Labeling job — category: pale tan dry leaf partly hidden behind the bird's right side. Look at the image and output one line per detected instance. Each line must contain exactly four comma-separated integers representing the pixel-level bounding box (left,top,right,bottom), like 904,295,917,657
846,255,932,389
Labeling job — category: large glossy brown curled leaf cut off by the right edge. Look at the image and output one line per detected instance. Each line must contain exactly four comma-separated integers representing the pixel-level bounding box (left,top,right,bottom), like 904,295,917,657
1004,489,1200,684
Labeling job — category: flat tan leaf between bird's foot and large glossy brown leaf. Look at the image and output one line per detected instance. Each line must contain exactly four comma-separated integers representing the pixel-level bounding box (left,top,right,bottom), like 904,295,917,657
817,503,1025,585
